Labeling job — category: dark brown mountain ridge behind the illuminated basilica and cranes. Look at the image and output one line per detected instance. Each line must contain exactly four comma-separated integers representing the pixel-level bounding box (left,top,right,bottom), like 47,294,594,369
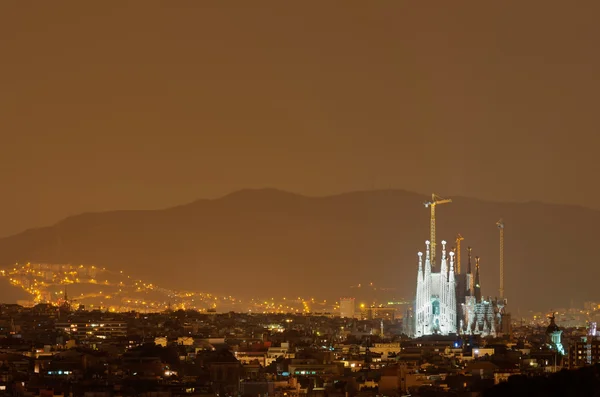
0,189,600,313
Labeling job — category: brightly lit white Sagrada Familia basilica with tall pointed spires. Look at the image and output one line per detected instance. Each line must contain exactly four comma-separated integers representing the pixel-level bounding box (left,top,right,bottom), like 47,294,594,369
405,241,510,338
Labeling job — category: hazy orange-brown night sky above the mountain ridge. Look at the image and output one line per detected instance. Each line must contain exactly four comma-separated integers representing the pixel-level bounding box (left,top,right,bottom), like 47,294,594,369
0,0,600,236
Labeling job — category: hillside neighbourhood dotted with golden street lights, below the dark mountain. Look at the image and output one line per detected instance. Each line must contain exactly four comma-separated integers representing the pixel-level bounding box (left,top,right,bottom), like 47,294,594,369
0,263,339,313
